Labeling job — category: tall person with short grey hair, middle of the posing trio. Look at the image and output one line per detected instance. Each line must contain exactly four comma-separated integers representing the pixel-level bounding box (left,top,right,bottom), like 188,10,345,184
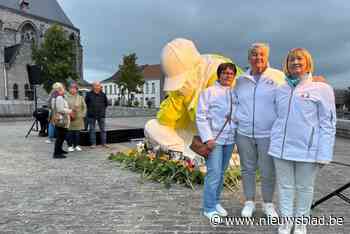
235,43,284,217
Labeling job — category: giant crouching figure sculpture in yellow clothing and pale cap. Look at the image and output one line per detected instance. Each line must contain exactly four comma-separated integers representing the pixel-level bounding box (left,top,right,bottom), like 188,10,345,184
145,38,242,158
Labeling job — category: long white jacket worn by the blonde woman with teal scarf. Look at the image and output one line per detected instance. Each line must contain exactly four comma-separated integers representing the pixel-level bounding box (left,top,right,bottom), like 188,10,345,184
269,74,336,163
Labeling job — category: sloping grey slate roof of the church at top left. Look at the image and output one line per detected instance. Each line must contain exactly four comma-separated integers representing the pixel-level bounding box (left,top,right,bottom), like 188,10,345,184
0,0,76,29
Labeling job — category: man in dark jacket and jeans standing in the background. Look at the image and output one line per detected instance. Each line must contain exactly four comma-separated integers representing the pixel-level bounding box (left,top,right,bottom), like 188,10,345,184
85,81,108,148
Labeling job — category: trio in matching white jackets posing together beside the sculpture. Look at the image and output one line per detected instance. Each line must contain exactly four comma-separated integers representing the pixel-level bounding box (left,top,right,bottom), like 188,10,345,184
196,43,336,234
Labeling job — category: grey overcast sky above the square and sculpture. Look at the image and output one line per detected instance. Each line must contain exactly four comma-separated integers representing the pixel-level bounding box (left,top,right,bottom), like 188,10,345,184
58,0,350,87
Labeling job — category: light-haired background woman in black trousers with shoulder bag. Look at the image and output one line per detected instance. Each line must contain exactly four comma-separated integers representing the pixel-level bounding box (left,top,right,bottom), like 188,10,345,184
51,83,72,159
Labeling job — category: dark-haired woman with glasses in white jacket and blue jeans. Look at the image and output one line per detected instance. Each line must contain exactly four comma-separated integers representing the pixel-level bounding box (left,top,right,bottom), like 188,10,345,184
196,63,237,220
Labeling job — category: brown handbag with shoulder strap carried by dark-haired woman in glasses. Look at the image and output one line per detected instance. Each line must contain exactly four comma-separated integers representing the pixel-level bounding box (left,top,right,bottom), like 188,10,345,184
190,90,232,158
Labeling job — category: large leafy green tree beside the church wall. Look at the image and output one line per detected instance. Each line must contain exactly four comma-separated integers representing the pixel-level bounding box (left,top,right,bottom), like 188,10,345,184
32,25,78,92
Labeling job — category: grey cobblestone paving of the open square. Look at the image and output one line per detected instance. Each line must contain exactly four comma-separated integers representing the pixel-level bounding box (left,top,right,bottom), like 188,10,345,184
0,118,350,234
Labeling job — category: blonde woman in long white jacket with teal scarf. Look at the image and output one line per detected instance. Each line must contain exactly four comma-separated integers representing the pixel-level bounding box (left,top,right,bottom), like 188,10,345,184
269,48,336,234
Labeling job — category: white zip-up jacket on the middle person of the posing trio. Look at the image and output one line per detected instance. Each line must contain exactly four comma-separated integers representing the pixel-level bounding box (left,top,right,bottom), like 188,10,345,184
234,67,285,138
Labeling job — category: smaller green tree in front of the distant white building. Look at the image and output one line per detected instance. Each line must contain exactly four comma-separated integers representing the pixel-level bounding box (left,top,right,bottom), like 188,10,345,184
116,53,145,103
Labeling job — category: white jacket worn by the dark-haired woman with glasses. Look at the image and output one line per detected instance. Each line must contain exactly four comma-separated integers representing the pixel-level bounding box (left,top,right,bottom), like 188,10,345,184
196,82,237,145
